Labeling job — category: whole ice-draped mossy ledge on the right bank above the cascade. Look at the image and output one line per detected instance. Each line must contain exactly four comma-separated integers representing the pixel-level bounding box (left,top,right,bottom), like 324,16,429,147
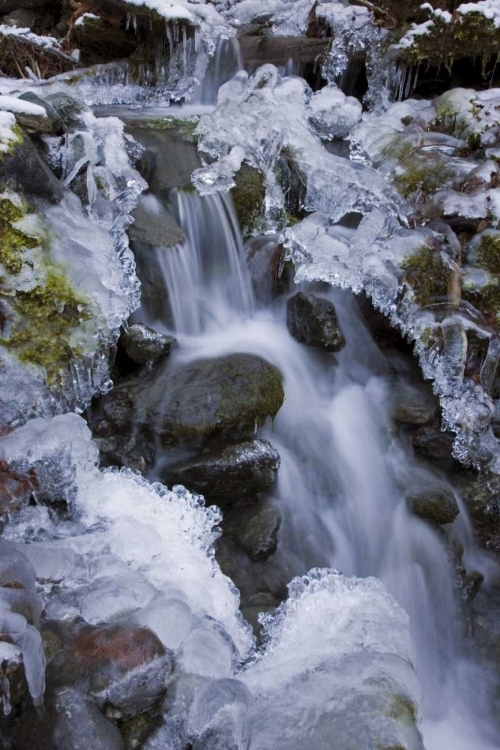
193,65,500,470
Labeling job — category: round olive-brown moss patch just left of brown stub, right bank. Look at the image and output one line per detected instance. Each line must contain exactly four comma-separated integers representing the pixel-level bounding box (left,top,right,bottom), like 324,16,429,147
401,245,450,306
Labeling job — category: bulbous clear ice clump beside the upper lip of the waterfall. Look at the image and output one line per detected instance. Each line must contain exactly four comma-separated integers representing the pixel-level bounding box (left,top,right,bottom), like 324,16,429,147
193,65,395,228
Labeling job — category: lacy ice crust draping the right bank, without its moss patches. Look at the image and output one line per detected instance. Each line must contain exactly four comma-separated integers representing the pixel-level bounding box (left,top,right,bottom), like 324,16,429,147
193,65,500,465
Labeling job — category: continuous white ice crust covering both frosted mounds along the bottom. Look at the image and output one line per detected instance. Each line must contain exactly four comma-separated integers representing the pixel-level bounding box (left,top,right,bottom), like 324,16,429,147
0,414,421,750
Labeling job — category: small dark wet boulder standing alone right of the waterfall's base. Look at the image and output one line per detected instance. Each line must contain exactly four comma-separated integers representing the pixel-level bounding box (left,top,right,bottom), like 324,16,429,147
287,292,345,352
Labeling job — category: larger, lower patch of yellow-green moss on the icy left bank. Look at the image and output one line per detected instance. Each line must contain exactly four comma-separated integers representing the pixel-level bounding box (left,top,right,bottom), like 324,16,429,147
1,264,88,384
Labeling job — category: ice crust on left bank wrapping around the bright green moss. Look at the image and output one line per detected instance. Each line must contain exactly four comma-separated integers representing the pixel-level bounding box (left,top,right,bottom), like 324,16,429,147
0,88,146,424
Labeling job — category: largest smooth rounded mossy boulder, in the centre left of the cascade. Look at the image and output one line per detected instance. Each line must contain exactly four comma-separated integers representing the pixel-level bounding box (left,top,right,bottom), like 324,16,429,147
103,354,284,448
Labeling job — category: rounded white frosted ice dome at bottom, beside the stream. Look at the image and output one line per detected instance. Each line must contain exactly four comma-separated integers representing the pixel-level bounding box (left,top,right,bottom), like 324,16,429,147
241,569,423,750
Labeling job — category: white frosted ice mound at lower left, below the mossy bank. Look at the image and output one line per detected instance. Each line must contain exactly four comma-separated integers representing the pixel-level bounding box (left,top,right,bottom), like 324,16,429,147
0,414,252,671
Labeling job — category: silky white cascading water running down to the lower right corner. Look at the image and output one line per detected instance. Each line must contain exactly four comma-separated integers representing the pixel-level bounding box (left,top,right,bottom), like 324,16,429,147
146,179,496,750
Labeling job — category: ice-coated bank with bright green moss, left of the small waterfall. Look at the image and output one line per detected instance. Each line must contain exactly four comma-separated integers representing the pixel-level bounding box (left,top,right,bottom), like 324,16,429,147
0,91,146,424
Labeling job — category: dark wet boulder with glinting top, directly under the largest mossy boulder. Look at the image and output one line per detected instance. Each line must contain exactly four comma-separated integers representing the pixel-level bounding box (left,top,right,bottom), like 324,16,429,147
163,440,280,506
